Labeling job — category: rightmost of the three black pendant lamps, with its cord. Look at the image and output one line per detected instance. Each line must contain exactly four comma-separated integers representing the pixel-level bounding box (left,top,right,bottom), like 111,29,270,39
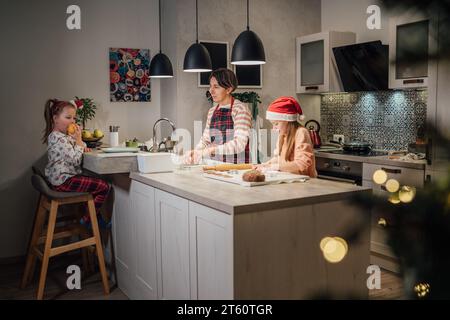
231,0,266,65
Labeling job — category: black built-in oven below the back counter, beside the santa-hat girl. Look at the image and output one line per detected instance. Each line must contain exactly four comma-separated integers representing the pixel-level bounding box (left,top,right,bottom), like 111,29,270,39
316,157,362,186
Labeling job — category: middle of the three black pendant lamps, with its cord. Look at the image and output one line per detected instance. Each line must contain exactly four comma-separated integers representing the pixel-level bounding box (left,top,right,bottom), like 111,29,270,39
183,0,212,72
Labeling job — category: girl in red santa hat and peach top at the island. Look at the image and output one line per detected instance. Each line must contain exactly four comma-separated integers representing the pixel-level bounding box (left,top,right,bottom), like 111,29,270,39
254,97,317,178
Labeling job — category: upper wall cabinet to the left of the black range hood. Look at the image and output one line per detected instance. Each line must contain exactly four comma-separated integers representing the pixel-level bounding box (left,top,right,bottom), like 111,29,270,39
296,31,356,93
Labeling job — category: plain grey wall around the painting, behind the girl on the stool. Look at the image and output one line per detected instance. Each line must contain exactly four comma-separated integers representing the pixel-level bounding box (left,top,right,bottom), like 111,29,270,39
0,0,160,258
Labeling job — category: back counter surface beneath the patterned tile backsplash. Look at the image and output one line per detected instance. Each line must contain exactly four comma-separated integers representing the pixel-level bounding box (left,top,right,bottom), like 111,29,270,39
315,151,426,170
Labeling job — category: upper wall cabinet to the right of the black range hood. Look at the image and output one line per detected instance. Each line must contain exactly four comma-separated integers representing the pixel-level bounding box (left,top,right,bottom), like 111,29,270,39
389,15,435,89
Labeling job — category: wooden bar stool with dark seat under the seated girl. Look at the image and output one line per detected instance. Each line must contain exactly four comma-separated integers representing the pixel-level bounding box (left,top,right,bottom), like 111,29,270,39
21,170,109,300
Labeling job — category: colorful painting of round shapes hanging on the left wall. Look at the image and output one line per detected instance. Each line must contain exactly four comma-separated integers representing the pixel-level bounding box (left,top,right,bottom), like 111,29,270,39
109,48,151,102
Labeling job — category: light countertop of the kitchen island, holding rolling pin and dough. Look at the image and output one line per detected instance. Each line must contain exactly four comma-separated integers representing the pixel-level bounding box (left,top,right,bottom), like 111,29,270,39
130,172,371,214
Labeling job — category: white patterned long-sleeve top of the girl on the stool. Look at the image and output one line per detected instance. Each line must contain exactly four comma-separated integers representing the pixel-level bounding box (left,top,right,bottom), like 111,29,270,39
45,131,84,186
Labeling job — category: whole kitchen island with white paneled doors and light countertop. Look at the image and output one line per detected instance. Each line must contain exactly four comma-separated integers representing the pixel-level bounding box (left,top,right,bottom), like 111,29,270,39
87,150,371,299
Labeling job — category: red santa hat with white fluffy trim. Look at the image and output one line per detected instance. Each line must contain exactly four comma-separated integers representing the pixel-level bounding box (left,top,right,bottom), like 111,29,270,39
266,97,305,121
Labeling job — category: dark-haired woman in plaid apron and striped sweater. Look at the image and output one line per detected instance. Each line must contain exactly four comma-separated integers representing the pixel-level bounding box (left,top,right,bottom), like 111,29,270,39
185,68,252,164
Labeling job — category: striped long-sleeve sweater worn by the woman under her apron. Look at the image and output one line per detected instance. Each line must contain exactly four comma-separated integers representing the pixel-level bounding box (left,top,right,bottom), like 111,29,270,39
195,99,252,155
